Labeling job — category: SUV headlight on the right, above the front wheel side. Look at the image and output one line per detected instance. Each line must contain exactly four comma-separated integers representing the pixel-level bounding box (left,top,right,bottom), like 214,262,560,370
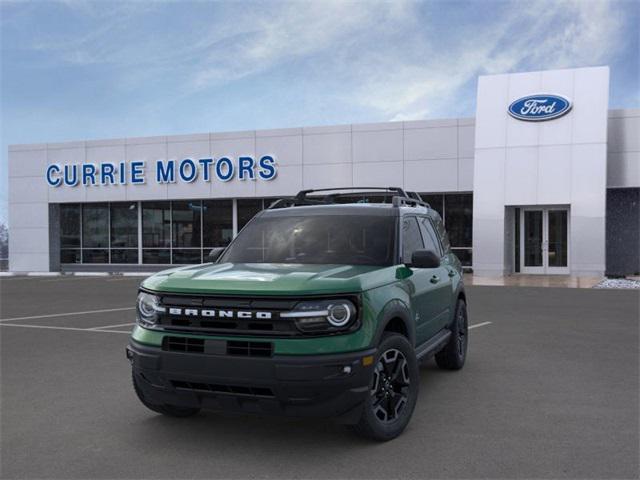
280,299,357,333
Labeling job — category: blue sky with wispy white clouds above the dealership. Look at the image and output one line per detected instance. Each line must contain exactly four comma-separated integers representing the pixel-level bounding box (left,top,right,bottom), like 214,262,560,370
0,0,640,226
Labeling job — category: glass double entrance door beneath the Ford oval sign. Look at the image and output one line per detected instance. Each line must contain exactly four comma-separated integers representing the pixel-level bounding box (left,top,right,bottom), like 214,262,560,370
519,207,569,274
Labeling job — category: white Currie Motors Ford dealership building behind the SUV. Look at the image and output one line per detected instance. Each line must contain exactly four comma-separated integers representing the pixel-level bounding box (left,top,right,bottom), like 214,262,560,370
9,67,640,276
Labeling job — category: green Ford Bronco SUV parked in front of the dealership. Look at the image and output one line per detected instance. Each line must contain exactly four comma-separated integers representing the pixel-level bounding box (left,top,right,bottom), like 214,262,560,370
127,187,468,440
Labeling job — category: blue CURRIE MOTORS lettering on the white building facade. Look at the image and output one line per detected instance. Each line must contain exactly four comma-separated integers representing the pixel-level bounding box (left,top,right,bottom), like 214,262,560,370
45,155,277,187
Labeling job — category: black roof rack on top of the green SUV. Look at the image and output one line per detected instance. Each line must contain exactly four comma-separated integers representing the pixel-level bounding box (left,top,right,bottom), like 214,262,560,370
268,187,431,209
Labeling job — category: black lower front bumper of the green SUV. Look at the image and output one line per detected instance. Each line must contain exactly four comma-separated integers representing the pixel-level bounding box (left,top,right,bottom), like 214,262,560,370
127,340,375,423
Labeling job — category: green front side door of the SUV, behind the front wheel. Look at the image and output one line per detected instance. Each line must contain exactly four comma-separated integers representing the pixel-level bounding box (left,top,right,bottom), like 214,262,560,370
402,216,434,345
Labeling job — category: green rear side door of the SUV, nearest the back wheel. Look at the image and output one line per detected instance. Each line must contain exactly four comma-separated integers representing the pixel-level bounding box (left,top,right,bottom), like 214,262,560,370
419,217,457,338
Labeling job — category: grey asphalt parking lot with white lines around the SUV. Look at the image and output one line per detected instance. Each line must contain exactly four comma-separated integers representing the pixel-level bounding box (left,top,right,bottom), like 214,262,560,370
0,277,640,478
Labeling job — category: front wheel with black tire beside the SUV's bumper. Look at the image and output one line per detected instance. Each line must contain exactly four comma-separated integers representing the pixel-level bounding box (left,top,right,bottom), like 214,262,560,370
351,333,420,442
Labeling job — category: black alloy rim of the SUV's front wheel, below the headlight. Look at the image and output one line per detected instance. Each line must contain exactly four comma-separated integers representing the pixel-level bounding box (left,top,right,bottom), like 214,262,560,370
371,348,411,423
